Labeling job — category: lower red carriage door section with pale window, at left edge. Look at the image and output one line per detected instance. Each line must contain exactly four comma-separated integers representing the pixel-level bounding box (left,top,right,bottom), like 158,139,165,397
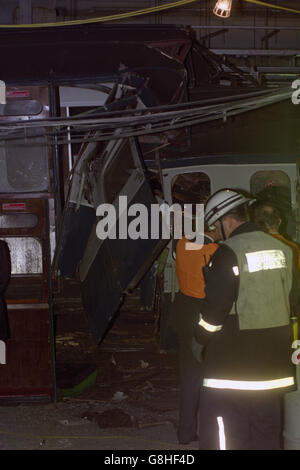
0,198,53,400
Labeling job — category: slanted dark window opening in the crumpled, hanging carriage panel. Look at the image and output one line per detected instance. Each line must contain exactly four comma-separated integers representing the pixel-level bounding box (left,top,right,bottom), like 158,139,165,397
105,139,134,203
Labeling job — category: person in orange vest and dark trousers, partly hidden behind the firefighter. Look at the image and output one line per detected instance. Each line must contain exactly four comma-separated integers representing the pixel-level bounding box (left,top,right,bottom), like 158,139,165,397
173,228,218,444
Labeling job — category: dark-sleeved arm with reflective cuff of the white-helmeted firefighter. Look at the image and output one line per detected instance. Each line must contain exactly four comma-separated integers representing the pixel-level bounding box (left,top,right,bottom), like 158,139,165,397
196,245,239,344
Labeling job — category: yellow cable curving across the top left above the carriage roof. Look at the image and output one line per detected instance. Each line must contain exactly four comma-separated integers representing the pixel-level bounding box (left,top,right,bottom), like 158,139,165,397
0,0,198,28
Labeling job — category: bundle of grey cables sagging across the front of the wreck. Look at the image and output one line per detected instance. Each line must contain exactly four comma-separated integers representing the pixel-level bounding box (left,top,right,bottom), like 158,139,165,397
0,88,292,145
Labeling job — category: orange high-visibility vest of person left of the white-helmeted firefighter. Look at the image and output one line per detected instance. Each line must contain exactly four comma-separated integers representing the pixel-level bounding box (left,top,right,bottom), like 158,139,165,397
176,237,218,299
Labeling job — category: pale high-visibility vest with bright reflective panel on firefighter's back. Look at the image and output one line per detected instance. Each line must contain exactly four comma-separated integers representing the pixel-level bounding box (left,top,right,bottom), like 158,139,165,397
225,232,293,330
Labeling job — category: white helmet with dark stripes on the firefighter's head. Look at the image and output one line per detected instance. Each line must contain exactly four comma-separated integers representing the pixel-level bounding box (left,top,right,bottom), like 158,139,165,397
204,189,255,226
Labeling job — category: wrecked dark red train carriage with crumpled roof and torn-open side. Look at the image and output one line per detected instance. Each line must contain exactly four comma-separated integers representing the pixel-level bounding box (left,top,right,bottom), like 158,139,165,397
0,25,286,394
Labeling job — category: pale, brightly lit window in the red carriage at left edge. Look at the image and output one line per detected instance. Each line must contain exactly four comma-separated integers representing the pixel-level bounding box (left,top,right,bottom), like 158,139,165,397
3,237,43,274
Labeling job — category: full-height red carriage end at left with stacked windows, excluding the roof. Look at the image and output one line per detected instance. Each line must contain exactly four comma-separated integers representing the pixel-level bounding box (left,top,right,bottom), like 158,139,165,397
0,87,55,402
